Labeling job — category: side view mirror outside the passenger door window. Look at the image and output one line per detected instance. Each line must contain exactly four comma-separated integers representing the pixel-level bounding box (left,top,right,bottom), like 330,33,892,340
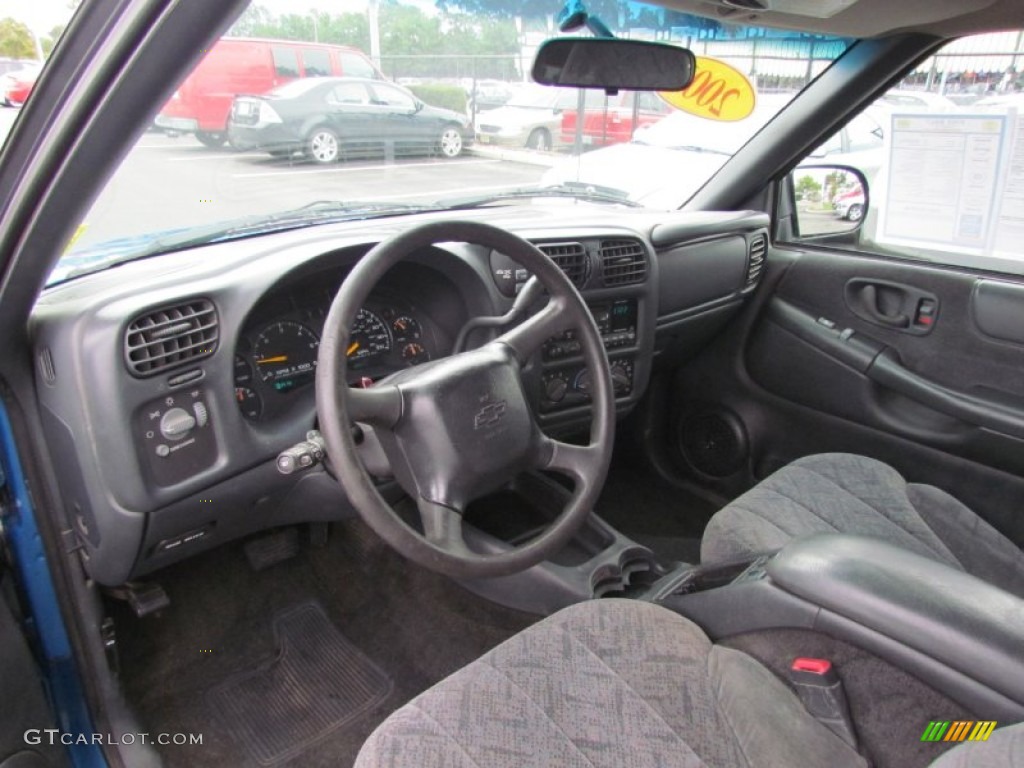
787,163,870,241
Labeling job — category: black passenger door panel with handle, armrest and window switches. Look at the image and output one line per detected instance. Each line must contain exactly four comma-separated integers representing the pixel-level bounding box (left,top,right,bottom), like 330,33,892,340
672,248,1024,545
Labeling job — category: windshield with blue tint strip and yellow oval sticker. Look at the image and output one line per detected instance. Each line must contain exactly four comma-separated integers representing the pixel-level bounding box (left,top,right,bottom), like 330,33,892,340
0,0,849,283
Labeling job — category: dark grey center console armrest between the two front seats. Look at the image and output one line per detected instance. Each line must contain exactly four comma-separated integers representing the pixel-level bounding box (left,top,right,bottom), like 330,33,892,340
647,535,1024,722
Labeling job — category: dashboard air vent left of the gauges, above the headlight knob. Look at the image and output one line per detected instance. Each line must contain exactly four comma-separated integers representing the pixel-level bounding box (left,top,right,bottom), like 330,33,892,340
125,299,218,377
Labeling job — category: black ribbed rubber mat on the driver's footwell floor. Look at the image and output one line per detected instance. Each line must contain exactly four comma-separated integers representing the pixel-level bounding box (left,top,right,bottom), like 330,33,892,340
207,602,392,766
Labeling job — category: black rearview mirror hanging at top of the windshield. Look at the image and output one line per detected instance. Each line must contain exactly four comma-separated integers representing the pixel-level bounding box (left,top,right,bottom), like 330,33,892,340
534,37,696,91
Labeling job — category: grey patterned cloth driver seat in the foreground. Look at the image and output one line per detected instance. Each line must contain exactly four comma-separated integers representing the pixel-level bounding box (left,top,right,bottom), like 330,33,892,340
355,599,1024,768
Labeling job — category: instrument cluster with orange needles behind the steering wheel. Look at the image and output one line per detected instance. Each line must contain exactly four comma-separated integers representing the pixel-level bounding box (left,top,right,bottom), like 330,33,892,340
234,287,438,422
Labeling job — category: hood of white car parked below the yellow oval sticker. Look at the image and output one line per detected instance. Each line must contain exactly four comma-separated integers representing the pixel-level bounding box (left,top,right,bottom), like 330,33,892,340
541,142,729,210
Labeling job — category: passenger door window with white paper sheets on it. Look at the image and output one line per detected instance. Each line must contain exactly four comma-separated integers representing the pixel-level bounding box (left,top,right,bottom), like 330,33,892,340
798,32,1024,273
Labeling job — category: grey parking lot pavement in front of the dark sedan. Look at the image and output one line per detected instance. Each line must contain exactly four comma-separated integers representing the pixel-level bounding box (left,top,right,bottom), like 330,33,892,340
76,133,545,247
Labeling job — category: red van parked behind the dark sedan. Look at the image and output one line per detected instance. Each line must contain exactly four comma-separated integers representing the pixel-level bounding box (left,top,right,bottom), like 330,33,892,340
156,37,384,147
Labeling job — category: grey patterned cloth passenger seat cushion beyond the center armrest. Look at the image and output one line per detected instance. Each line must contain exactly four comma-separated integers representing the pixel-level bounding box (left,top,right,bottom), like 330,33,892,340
700,454,1024,597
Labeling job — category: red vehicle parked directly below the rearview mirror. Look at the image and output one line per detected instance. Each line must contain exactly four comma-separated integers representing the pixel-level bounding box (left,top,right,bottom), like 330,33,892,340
561,90,672,146
